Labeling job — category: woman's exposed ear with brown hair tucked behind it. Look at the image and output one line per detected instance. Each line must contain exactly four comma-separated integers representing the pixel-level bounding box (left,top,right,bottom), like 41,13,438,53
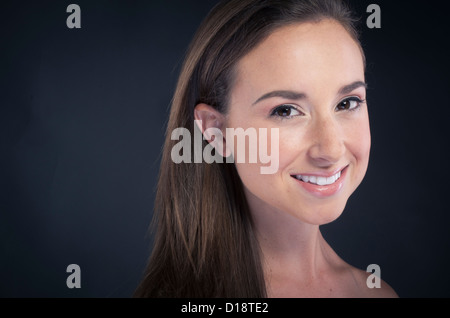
194,103,229,157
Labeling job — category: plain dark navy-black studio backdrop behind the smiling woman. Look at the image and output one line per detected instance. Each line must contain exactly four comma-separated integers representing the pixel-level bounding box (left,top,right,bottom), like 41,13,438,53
0,0,450,297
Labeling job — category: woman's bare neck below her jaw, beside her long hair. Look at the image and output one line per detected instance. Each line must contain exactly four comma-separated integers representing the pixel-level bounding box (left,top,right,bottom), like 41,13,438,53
249,196,335,296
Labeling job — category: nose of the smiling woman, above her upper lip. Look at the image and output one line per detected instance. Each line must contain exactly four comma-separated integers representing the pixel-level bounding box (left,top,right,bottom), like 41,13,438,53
308,118,345,168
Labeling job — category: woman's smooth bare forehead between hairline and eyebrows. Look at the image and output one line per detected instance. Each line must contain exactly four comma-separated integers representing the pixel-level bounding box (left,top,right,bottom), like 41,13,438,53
235,20,364,100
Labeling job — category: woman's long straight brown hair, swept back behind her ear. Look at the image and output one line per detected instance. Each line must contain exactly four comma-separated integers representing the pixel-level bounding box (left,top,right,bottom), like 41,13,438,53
134,0,359,297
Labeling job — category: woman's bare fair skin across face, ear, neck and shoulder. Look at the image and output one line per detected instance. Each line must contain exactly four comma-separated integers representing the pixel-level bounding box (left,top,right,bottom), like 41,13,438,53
195,20,397,297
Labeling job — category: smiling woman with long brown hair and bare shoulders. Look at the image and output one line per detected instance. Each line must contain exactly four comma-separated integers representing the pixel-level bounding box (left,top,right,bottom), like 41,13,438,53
135,0,396,297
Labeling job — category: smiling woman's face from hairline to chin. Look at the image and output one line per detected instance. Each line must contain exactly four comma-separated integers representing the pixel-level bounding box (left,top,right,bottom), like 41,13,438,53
225,20,370,225
